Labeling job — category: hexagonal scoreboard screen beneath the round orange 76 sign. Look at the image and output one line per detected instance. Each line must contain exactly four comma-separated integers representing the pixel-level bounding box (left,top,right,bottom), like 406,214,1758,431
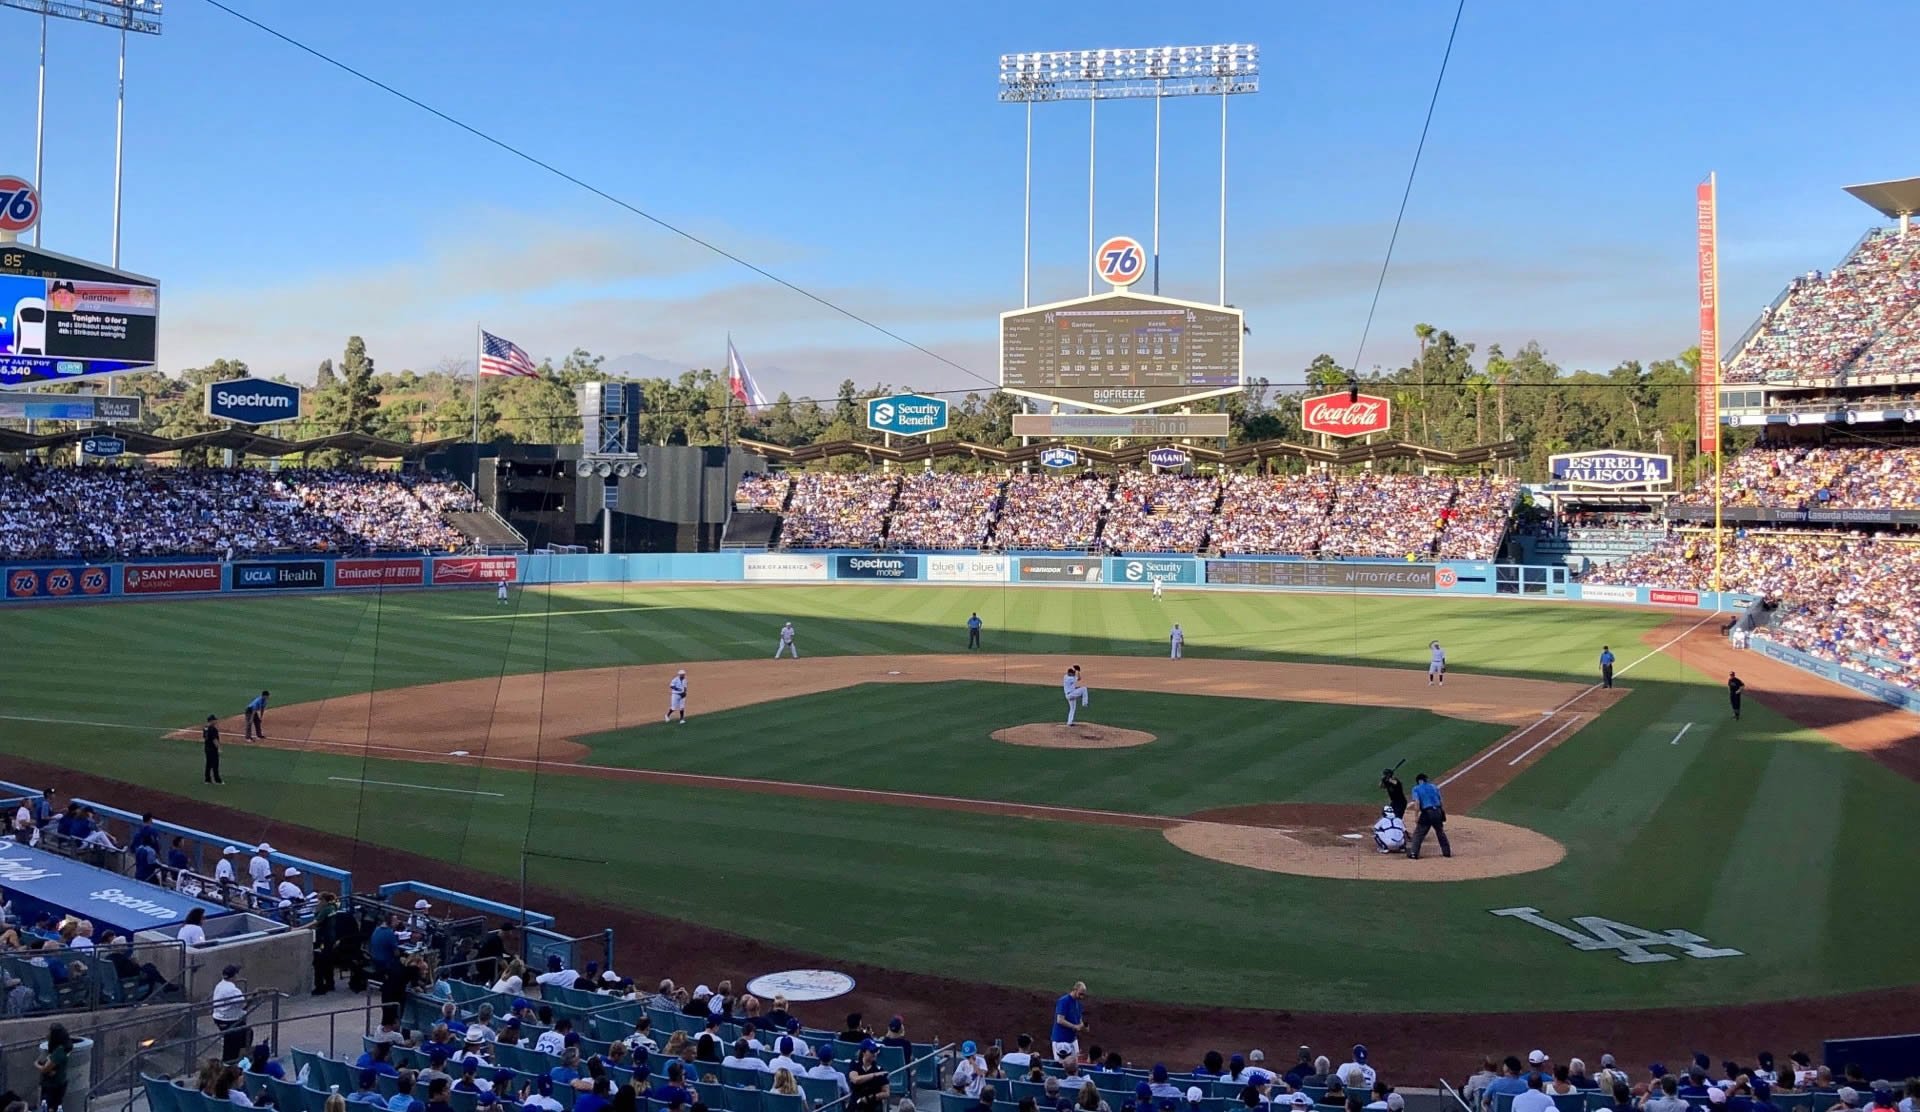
1000,294,1242,409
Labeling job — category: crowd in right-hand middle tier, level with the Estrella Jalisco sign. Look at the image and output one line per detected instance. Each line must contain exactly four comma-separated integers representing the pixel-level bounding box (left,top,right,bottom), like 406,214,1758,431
1678,446,1920,509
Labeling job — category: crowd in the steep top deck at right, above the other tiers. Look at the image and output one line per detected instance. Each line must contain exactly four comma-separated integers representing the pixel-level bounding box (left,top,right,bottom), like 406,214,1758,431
1724,229,1920,382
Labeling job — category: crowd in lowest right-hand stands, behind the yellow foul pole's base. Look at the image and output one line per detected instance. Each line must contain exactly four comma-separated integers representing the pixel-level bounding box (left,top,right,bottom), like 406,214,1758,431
1582,530,1920,689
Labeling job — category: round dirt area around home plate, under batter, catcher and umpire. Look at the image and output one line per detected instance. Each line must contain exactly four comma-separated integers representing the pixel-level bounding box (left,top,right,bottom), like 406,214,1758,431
1165,814,1567,882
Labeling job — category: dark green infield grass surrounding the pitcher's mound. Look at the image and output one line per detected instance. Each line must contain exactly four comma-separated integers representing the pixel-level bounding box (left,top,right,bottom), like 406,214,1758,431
576,682,1511,814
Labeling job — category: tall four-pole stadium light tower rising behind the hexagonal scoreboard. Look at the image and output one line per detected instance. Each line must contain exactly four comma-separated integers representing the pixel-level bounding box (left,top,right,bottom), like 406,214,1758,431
1000,42,1260,305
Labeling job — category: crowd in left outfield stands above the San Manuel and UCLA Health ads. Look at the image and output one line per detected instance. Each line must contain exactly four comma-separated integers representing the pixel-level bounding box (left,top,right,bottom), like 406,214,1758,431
0,467,478,559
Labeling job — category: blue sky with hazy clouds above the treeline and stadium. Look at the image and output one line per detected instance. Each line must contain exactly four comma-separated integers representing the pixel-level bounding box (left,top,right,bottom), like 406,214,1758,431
0,0,1920,396
